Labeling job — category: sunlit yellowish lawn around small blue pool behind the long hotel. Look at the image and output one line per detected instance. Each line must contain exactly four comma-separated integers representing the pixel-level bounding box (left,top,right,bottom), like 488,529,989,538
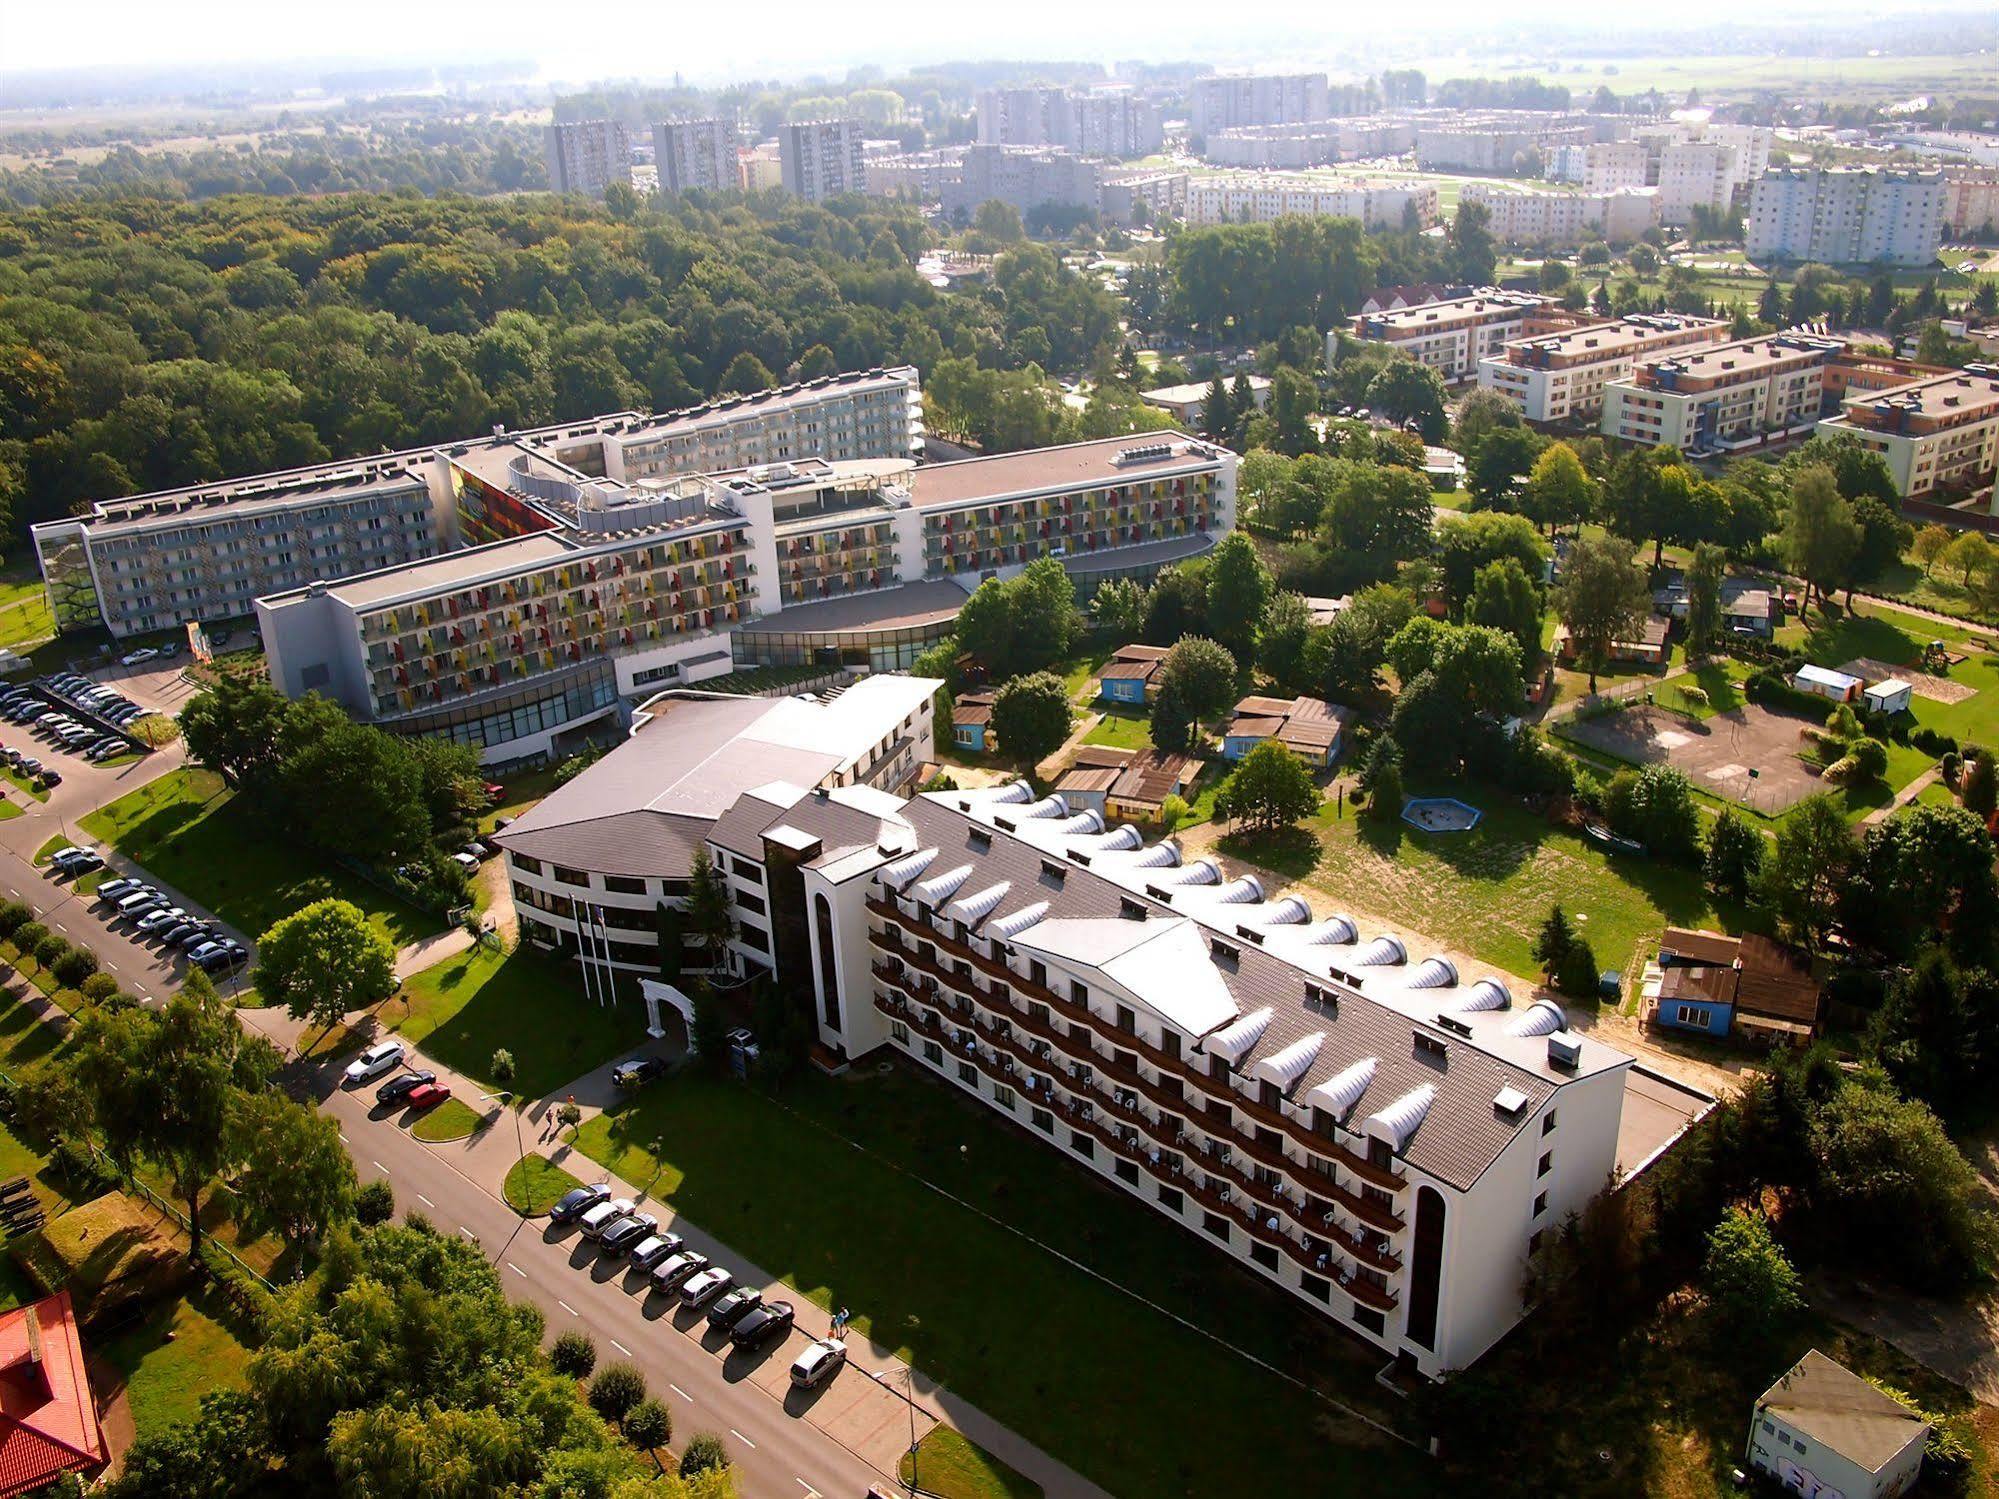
1305,783,1743,977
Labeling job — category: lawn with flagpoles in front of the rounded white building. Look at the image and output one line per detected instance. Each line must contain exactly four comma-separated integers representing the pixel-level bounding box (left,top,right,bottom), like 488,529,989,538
384,947,646,1097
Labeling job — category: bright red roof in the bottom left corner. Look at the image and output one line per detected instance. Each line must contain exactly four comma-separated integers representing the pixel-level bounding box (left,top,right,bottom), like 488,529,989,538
0,1291,110,1499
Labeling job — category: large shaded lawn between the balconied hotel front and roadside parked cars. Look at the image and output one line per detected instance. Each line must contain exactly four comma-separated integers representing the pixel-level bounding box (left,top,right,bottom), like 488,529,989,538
578,1069,1439,1495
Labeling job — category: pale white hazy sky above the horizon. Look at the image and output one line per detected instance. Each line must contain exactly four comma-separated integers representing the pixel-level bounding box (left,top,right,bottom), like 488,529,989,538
0,0,1989,85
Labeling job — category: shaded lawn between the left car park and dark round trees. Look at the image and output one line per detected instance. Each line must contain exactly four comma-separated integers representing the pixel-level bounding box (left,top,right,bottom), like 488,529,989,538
80,769,438,947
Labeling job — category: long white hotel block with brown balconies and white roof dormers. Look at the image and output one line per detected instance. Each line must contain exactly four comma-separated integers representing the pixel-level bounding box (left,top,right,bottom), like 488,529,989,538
500,775,1707,1377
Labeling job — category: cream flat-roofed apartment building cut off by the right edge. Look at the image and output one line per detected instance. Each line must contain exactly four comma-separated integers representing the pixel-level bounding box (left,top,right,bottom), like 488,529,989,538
1819,364,1999,500
